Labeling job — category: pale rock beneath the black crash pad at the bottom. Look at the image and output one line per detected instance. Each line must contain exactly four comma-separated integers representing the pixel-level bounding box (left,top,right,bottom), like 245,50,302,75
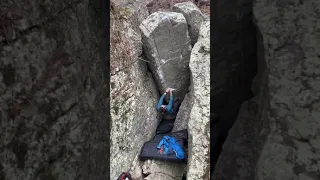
142,160,186,180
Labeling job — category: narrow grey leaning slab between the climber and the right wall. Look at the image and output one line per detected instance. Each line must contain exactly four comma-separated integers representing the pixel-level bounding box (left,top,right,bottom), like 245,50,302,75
172,93,193,132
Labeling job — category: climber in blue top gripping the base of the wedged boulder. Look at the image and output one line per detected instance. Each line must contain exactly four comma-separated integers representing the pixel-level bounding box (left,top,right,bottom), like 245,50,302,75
157,88,181,119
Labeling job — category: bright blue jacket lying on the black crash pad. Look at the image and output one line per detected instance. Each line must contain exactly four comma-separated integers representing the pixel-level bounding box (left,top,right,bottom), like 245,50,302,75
157,136,184,159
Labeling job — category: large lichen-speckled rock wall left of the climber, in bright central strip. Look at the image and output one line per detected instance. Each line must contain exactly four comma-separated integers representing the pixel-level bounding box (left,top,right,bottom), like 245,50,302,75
110,3,159,179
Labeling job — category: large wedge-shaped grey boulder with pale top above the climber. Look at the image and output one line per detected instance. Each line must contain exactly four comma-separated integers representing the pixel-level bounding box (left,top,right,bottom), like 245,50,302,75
140,12,191,99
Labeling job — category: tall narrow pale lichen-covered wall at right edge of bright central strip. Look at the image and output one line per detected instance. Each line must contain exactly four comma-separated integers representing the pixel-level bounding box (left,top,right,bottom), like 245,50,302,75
187,21,210,180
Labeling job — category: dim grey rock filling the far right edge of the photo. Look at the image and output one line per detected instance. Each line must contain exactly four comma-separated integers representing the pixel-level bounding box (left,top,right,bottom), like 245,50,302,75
254,0,320,179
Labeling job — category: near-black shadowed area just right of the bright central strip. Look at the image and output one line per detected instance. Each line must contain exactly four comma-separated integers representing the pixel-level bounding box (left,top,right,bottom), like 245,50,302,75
210,0,257,168
